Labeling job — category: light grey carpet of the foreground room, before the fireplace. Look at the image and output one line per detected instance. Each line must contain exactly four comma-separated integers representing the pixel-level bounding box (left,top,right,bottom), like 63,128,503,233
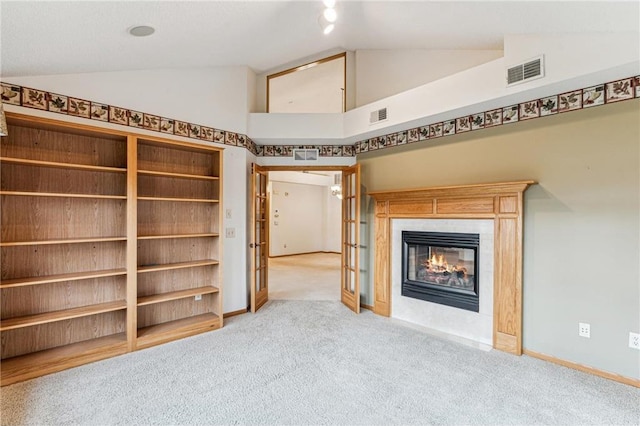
2,300,640,425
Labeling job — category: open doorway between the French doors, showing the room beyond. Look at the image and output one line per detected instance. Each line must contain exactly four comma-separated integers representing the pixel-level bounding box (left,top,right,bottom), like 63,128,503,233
267,171,342,300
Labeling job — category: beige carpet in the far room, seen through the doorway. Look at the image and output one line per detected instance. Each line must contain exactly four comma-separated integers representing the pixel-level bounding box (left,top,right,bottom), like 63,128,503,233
269,253,340,300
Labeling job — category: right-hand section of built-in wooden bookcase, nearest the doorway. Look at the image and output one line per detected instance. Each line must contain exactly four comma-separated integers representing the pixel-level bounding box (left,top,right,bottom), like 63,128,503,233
137,139,222,346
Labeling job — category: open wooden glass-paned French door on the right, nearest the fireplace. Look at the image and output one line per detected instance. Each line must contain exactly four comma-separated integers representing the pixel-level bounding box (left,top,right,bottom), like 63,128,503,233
341,164,360,314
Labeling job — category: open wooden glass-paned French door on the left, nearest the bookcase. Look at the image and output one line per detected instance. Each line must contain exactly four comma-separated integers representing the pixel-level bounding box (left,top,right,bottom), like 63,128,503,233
249,164,269,312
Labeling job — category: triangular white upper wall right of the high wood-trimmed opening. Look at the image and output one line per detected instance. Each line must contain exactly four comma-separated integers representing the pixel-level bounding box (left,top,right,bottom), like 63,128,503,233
355,49,502,107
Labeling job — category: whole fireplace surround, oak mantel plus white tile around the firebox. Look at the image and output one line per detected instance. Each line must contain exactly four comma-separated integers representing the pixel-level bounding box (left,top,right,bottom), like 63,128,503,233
369,181,535,355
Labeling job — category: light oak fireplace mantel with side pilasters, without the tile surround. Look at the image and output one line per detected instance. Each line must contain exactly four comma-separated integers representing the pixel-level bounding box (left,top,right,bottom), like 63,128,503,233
369,180,536,355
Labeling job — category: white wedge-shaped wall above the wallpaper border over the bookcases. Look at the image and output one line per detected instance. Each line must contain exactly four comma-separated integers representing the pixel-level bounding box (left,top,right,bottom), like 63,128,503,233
3,67,252,134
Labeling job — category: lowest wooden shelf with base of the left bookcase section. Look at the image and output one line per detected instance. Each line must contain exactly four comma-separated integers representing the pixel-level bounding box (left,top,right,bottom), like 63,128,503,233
1,333,128,386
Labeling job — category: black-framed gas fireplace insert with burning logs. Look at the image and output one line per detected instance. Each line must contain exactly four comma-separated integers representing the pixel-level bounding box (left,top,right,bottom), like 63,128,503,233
401,231,480,312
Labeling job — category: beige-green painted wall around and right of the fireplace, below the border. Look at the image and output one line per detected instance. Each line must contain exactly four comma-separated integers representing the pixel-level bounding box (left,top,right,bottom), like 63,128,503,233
358,99,640,379
